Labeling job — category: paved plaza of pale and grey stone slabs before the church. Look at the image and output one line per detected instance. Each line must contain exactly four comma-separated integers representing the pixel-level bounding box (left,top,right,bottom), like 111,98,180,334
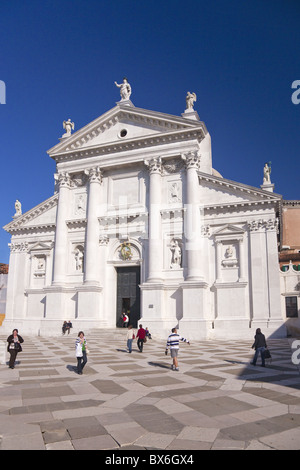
0,329,300,451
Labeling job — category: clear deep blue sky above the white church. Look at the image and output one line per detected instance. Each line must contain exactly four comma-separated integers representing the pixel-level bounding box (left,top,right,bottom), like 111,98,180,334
0,0,300,263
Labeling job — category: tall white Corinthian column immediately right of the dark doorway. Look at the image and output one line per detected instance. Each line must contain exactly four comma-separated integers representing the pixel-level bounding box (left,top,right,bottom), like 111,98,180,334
145,158,163,282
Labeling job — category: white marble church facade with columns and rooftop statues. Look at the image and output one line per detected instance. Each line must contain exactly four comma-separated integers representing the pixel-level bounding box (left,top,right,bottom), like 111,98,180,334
3,81,285,339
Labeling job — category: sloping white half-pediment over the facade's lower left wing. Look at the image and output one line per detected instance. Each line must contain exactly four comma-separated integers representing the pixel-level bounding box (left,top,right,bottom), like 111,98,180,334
3,193,58,233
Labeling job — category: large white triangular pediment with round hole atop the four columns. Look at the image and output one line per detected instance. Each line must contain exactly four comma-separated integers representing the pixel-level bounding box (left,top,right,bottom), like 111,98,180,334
47,103,207,159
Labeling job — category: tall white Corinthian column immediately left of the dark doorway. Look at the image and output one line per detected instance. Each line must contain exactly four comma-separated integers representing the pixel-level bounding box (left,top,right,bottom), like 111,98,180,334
84,168,102,285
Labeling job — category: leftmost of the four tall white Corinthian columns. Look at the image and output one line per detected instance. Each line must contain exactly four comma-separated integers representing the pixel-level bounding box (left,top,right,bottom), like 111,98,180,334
52,173,71,285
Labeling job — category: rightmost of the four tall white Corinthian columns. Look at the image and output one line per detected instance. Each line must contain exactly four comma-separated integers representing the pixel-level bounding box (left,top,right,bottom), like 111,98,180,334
182,151,203,281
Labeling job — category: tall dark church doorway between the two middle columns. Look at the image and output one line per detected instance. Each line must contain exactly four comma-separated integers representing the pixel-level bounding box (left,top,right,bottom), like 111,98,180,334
116,266,140,328
